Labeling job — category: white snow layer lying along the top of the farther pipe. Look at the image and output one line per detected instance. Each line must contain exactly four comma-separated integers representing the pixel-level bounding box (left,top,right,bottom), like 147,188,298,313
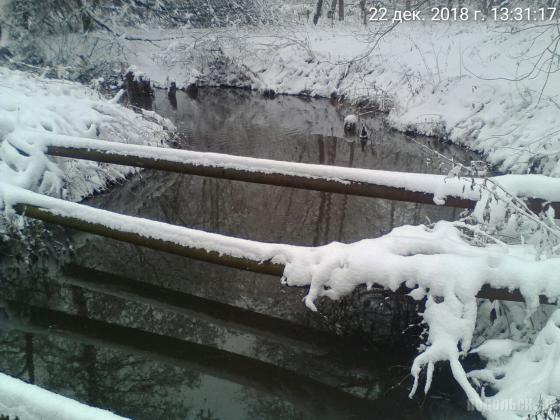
19,131,560,209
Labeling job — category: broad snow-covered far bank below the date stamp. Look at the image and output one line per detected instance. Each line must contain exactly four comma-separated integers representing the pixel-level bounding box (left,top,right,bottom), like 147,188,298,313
121,22,560,176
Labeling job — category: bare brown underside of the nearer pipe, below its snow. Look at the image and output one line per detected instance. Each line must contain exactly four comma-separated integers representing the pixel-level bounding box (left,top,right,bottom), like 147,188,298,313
14,199,548,303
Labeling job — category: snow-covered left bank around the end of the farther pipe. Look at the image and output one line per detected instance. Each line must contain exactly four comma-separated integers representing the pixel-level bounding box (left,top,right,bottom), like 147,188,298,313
0,67,172,200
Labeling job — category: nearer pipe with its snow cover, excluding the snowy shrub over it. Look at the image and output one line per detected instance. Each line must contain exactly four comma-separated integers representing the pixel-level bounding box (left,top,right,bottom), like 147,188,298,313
4,184,547,303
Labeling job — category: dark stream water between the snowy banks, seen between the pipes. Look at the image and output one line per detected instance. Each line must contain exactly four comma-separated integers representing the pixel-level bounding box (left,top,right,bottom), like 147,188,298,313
0,89,477,420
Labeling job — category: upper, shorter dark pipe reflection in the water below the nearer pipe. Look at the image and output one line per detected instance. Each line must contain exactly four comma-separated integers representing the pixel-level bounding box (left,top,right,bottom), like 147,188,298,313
62,265,331,351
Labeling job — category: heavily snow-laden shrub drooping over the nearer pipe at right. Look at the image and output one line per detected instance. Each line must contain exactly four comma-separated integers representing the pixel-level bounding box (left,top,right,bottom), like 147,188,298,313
279,217,560,419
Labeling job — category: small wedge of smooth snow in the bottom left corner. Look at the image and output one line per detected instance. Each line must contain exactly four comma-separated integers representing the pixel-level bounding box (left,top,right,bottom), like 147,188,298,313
0,373,124,420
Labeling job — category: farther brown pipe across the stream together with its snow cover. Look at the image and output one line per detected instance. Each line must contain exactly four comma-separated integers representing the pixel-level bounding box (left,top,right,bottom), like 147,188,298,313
39,134,560,214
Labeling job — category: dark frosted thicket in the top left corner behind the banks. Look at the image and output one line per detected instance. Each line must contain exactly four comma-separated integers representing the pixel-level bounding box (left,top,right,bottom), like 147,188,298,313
0,0,271,69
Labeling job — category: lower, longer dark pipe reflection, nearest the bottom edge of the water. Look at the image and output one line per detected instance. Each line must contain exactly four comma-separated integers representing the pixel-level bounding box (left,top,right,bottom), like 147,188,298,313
1,302,395,419
